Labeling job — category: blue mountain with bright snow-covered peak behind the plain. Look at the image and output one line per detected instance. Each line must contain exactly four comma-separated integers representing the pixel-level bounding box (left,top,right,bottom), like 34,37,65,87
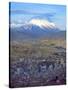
10,19,66,40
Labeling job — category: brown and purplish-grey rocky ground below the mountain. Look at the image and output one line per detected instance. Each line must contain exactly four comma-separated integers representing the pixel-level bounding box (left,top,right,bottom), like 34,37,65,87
10,40,66,88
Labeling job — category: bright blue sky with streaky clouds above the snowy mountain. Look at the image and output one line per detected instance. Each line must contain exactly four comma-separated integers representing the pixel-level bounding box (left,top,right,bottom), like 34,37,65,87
10,2,66,30
